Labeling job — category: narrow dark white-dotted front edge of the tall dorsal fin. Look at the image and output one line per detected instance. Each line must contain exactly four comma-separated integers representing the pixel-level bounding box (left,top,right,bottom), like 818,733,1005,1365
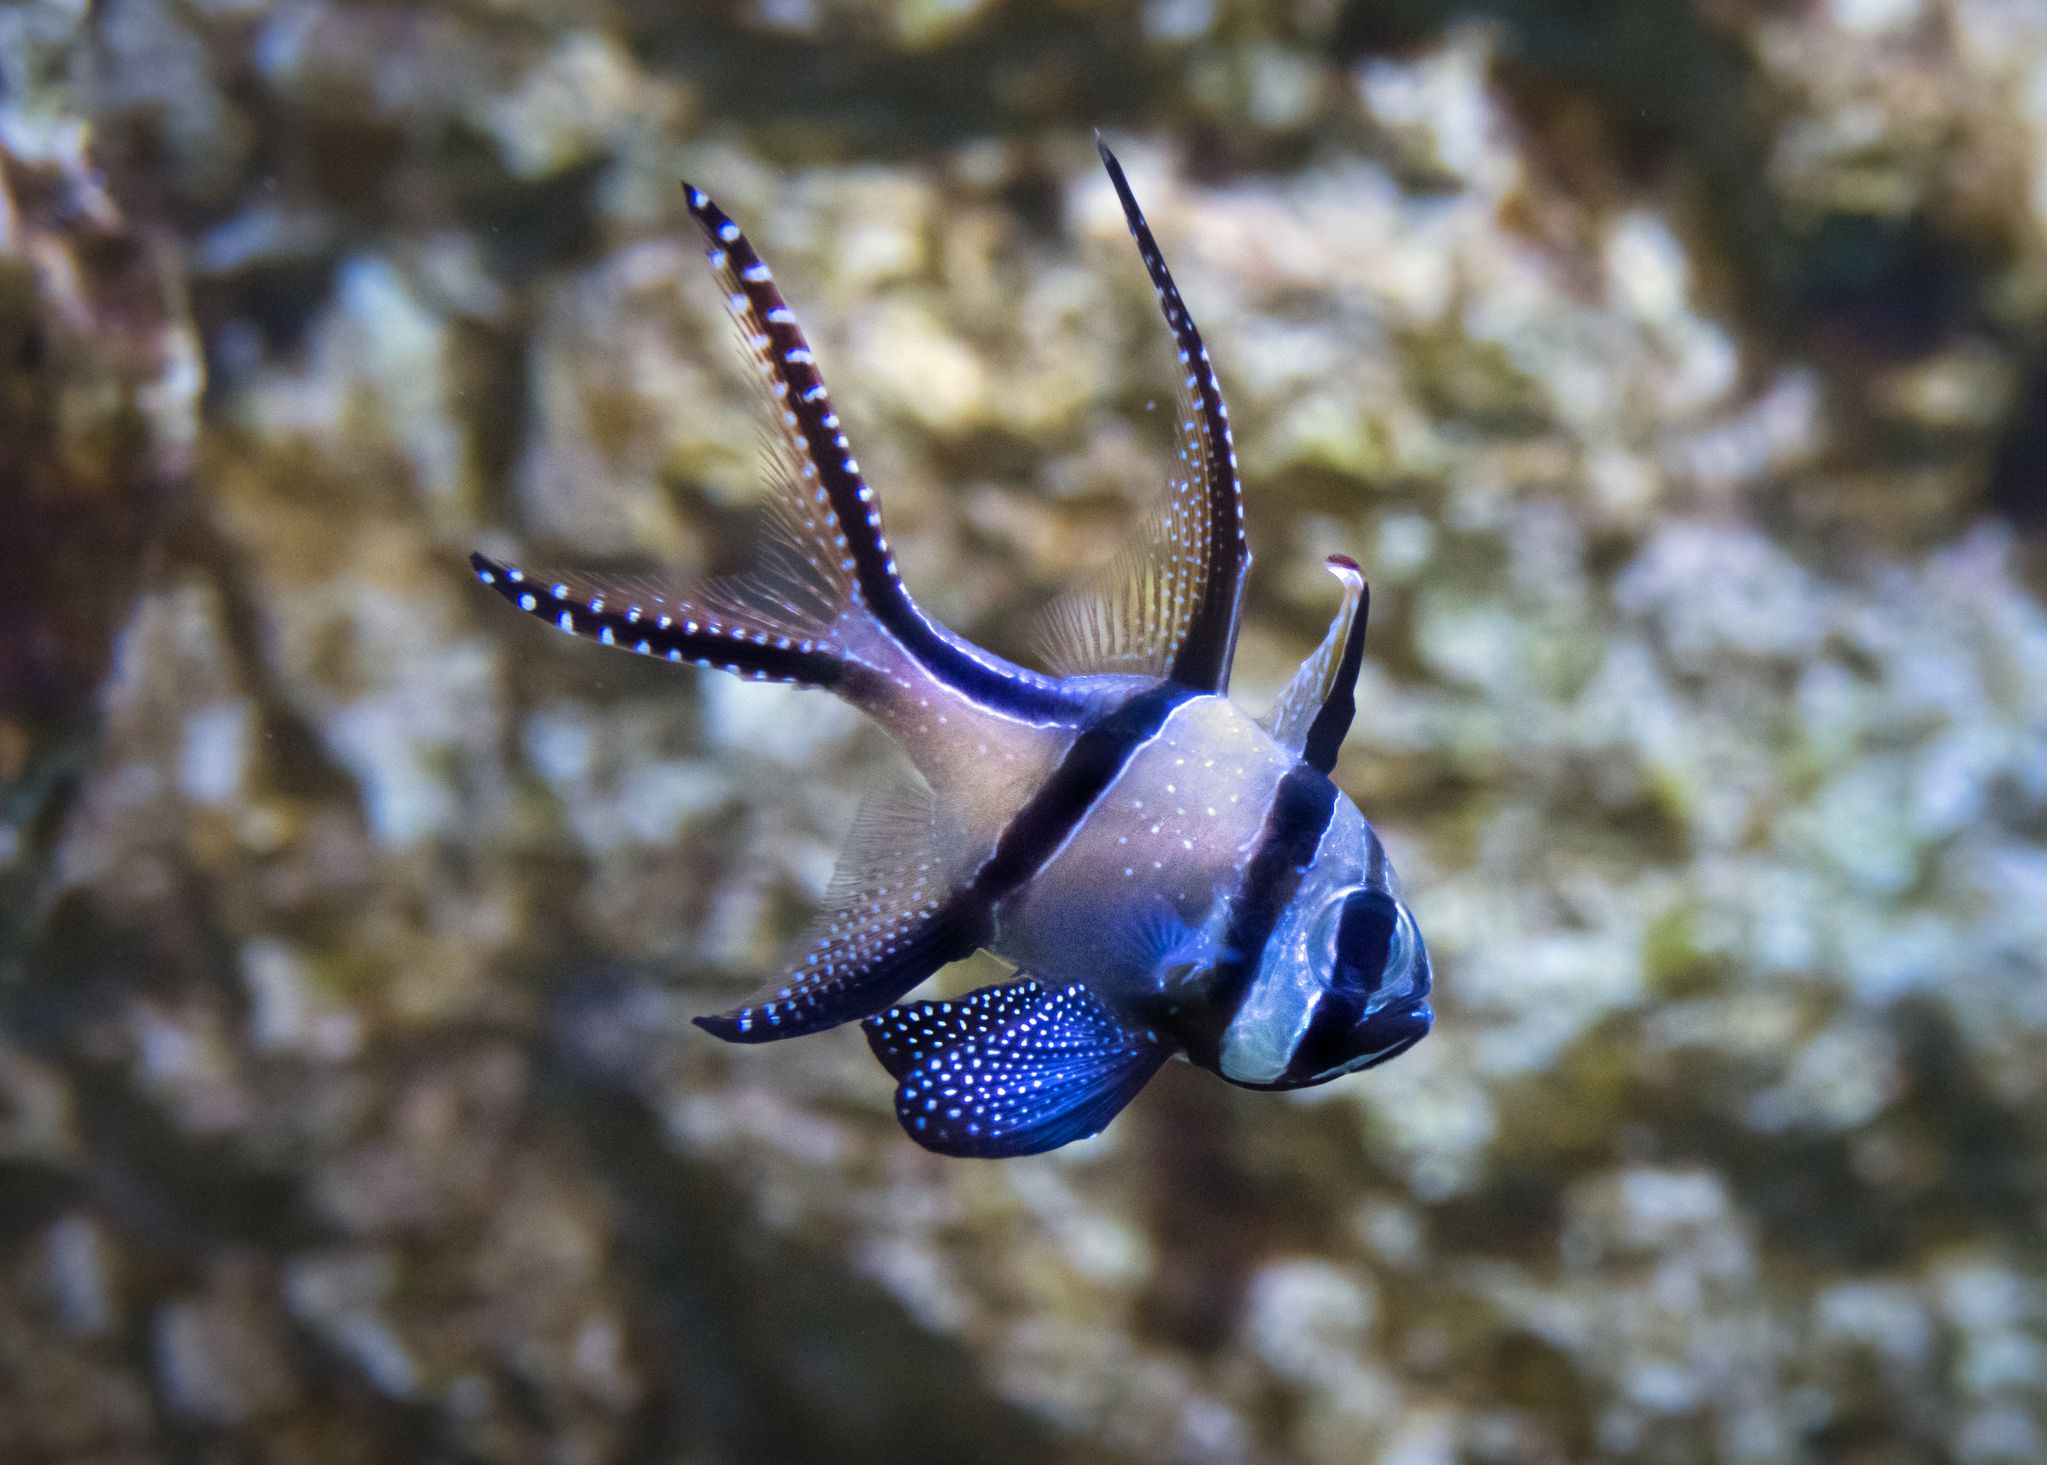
1095,137,1251,692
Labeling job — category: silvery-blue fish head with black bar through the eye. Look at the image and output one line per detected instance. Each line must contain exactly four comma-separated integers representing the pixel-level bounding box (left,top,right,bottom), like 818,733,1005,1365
1210,794,1435,1089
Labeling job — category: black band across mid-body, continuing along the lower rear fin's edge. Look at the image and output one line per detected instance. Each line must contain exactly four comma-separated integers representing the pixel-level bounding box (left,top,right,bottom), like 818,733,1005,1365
694,681,1197,1044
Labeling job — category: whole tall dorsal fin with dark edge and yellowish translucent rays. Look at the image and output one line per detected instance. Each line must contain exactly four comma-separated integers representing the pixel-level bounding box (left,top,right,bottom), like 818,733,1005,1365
1040,139,1251,692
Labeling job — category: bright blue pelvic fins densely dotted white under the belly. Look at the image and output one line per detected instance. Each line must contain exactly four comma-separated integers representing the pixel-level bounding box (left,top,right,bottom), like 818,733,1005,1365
866,982,1173,1160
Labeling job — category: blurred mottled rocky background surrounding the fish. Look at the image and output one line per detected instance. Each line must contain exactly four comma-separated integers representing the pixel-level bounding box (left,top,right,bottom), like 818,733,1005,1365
0,0,2047,1465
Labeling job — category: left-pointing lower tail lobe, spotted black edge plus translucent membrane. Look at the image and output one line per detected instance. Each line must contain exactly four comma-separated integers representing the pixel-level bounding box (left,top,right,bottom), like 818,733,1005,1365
469,554,847,687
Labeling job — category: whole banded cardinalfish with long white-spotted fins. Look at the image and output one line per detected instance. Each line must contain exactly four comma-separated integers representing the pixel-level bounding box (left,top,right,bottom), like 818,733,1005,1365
473,147,1431,1156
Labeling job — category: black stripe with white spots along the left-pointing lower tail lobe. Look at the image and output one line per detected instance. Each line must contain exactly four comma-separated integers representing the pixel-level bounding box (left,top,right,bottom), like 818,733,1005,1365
469,554,868,692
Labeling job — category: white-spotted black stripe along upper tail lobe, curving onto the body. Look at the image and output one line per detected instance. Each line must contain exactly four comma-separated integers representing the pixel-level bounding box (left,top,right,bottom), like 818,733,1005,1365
684,184,1081,720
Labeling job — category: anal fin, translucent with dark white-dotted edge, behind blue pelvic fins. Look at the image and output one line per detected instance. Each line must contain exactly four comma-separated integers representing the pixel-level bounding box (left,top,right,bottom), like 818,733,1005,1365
696,784,985,1044
